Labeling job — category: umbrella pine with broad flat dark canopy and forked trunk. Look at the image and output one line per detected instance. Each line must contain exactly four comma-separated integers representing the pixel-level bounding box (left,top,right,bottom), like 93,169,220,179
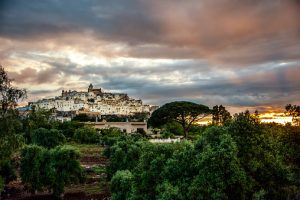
149,101,210,138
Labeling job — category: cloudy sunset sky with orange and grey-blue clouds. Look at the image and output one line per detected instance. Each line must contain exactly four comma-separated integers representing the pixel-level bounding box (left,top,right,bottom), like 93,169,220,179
0,0,300,112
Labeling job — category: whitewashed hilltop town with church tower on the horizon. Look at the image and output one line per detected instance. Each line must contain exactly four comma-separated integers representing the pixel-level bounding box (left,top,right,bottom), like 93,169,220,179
31,84,158,120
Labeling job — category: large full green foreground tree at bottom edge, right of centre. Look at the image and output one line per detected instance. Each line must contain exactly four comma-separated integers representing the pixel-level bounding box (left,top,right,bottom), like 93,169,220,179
189,127,246,199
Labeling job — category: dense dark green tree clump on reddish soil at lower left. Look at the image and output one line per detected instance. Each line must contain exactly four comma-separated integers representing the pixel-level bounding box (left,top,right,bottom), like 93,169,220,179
21,145,84,196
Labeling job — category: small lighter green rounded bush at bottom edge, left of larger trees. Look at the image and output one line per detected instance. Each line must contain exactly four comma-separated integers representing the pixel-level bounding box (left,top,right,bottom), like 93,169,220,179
111,170,133,200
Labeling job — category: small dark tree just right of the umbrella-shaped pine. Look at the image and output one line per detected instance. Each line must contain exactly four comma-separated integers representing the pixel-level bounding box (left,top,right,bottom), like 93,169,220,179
212,105,232,125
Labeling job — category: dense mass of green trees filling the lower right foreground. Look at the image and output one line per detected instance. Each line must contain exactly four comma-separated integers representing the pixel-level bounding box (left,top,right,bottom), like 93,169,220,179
106,108,300,199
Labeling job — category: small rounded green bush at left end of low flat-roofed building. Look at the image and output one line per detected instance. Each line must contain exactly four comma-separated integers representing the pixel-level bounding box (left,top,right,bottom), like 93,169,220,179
74,126,99,144
